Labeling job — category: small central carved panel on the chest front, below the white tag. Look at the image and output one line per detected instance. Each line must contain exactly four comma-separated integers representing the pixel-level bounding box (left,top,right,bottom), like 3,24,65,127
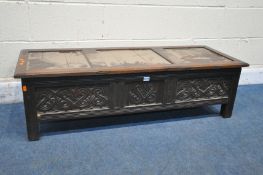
128,82,159,105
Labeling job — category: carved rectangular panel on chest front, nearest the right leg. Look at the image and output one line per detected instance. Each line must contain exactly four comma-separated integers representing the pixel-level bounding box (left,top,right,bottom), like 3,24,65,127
175,78,230,102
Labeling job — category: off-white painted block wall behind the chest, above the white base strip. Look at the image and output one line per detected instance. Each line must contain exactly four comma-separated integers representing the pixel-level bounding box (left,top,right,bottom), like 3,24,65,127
0,0,263,78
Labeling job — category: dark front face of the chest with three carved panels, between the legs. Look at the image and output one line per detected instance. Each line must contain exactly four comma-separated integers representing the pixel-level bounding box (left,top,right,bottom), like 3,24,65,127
22,70,238,120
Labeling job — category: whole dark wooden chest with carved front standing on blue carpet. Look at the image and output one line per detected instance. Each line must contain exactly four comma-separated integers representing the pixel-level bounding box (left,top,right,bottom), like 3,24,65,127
14,46,248,140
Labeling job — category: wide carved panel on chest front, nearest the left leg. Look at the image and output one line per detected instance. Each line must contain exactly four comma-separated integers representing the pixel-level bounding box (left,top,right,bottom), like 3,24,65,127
36,86,109,112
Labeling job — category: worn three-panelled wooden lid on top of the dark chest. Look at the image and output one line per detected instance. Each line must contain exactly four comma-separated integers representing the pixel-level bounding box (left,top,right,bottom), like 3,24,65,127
14,46,248,78
